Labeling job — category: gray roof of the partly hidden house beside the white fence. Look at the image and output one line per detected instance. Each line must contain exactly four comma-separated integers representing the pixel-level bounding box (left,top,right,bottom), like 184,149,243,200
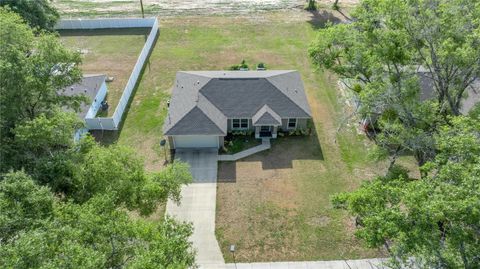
58,75,107,120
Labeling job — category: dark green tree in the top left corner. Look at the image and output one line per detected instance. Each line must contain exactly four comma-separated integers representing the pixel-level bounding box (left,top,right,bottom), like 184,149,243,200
0,0,60,31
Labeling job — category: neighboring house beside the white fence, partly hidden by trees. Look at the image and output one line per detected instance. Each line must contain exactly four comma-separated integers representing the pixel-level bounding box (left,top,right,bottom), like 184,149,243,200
59,75,107,141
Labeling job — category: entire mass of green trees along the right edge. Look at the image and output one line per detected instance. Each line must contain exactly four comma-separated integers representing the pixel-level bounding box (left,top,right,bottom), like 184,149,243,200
309,0,480,268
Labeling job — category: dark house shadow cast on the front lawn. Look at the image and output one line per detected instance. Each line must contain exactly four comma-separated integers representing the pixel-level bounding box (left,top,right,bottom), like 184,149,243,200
217,133,324,183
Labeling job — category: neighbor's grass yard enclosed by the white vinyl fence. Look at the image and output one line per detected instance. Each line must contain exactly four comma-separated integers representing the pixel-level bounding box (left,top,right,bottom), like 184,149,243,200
60,30,145,116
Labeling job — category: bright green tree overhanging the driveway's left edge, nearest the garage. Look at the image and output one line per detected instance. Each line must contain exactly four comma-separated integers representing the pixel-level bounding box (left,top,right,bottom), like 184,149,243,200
72,141,192,215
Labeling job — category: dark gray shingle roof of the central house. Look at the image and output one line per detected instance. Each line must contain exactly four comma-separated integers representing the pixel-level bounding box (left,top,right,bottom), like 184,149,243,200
164,70,311,135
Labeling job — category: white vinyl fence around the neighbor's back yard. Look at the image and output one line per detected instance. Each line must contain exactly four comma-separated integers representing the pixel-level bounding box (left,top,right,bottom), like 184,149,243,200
56,18,158,130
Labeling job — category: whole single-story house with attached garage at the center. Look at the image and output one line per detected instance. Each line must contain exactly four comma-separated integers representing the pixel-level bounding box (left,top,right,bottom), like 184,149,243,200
163,70,312,149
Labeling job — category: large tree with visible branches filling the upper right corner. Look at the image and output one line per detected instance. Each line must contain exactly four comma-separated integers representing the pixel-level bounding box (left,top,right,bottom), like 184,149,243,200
309,0,480,166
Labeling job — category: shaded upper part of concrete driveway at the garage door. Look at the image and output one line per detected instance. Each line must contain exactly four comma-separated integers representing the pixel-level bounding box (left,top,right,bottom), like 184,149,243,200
175,149,218,183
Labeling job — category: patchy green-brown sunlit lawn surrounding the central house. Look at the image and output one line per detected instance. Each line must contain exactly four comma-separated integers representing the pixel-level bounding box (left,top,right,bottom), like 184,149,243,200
57,10,416,261
